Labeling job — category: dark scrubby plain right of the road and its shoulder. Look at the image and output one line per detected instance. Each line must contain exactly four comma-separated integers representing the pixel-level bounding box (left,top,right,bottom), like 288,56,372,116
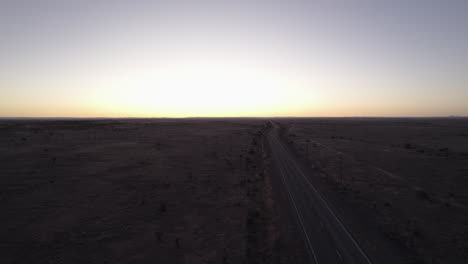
278,118,468,263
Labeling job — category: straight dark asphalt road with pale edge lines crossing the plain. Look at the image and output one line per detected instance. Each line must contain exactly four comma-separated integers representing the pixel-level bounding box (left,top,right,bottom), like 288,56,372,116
267,123,373,264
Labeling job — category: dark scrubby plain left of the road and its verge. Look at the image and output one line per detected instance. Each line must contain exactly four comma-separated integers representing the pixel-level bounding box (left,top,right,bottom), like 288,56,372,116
0,119,271,263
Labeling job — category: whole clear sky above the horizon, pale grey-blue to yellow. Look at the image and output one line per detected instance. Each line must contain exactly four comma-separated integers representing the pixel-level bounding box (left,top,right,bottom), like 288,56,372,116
0,0,468,117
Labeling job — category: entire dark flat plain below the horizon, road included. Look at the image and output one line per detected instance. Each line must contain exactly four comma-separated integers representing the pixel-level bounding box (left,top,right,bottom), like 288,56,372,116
0,118,468,264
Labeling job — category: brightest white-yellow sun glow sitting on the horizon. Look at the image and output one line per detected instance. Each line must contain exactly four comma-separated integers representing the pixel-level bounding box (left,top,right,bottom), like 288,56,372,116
96,59,314,117
